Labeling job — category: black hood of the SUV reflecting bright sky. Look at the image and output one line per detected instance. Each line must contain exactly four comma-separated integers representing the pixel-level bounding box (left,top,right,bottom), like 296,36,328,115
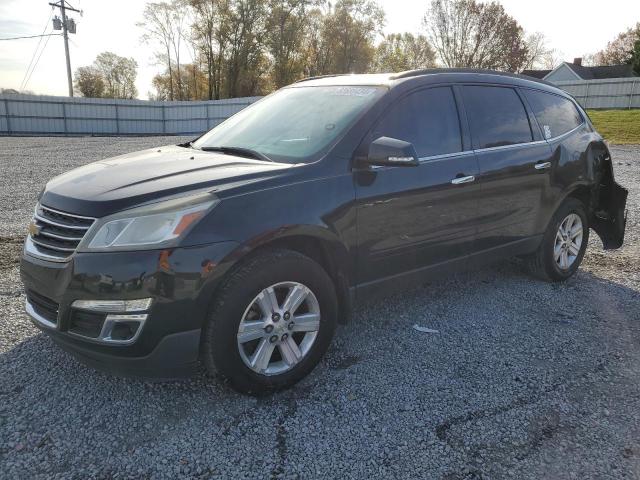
40,145,293,217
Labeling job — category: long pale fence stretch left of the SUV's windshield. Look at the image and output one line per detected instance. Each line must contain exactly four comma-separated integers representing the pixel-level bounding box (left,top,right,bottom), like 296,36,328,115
0,95,260,135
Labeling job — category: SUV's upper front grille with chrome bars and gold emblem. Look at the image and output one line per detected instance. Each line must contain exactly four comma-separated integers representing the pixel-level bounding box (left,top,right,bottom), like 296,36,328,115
29,204,95,260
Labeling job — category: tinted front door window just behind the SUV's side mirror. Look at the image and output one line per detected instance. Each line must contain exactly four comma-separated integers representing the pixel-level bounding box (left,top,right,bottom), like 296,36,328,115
374,87,462,157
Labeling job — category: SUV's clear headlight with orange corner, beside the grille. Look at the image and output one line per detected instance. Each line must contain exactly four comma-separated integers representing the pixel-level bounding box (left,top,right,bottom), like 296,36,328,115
78,193,220,252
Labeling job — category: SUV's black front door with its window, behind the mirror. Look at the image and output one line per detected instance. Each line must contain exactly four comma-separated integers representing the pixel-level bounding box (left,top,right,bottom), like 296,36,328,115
354,86,479,284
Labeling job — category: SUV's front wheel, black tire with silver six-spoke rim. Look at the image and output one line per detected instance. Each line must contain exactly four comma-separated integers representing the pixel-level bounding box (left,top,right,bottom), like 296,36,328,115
201,249,338,395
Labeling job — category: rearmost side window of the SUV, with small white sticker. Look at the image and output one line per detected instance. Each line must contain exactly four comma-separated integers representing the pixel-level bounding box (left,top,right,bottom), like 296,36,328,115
524,90,582,138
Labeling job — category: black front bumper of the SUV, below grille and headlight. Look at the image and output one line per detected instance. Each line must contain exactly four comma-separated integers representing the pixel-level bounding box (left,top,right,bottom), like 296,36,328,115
20,242,238,378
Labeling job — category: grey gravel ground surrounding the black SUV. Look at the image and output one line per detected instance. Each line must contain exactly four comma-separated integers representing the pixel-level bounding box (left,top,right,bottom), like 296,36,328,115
0,138,640,479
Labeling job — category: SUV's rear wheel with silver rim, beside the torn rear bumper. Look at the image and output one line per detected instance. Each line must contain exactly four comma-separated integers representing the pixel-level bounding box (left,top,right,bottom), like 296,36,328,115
525,198,589,282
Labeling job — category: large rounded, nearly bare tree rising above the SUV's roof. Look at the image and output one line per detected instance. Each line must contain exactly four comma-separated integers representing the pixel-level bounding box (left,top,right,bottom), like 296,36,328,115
424,0,527,72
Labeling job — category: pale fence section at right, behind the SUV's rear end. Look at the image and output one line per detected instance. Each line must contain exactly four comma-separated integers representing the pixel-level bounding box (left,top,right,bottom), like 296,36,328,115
554,77,640,109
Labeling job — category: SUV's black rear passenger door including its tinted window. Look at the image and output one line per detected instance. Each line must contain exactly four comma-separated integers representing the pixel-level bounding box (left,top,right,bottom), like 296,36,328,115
461,85,551,251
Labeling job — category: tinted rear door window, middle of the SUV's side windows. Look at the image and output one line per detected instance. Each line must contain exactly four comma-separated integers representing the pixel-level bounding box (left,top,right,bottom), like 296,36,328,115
462,86,533,148
